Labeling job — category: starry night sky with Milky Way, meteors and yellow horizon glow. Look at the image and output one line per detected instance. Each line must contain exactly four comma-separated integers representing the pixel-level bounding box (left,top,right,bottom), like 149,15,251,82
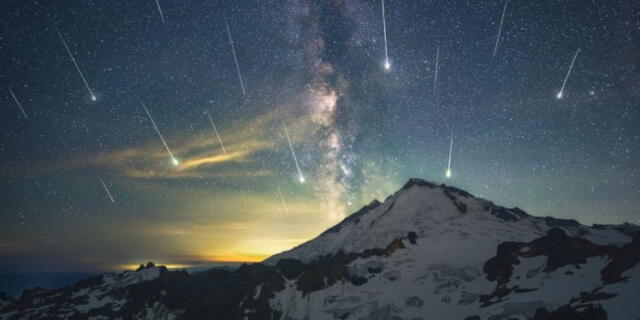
0,0,640,272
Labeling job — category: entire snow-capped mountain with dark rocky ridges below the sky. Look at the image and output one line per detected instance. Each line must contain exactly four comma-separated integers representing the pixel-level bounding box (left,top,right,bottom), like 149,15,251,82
0,179,640,320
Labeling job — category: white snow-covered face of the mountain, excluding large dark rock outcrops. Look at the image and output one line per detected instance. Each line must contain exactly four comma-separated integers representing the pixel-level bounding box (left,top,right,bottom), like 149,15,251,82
265,180,640,319
